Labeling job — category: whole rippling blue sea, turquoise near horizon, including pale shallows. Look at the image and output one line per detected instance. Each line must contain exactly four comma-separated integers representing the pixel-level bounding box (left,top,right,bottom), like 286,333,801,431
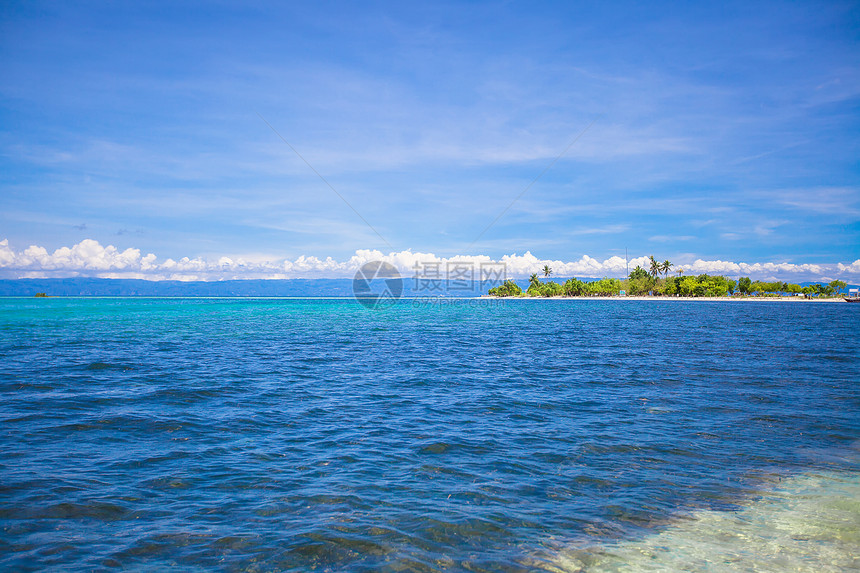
0,298,860,572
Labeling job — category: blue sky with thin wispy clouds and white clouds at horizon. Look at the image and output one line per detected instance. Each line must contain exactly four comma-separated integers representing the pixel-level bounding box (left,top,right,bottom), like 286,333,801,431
0,1,860,282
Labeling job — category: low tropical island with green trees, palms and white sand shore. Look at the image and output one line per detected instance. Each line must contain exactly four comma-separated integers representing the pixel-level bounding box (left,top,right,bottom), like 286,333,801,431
487,256,848,299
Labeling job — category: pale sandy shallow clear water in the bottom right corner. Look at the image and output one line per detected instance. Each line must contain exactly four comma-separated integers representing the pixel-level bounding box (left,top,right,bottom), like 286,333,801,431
540,472,860,573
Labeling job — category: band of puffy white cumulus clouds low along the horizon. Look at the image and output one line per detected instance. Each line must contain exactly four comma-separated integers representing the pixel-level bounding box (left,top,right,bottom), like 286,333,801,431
0,239,860,281
